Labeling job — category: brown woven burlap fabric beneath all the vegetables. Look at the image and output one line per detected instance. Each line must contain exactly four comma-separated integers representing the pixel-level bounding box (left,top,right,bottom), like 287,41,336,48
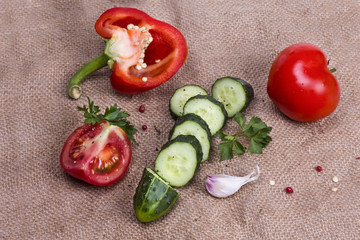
0,0,360,239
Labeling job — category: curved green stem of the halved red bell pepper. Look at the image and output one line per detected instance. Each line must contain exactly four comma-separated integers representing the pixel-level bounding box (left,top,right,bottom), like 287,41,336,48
67,53,109,99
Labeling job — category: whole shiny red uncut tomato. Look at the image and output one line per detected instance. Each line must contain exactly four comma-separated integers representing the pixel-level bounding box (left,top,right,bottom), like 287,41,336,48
267,43,340,122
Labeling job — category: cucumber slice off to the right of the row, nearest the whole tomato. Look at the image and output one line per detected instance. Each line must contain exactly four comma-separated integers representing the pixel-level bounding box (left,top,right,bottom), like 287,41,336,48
211,77,254,117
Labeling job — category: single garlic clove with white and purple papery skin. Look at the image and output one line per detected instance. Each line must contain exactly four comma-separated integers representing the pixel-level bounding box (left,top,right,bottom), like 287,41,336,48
206,166,260,198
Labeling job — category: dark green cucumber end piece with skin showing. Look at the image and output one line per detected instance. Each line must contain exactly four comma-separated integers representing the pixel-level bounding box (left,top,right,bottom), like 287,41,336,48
133,168,180,222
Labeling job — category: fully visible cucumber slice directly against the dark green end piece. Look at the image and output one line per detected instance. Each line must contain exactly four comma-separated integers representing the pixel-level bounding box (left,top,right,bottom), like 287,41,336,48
155,135,202,187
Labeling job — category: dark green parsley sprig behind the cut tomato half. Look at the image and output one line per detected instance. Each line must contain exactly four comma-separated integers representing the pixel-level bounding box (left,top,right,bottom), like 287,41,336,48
77,97,137,143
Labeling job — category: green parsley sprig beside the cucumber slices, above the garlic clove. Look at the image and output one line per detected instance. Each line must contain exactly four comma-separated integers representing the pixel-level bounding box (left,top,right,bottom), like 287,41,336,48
216,112,272,161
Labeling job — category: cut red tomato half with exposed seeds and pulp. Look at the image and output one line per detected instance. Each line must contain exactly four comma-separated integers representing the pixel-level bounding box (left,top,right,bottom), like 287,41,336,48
60,121,131,186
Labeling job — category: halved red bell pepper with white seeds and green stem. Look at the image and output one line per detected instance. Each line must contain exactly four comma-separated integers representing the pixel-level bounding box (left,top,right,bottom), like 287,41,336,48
67,7,187,99
